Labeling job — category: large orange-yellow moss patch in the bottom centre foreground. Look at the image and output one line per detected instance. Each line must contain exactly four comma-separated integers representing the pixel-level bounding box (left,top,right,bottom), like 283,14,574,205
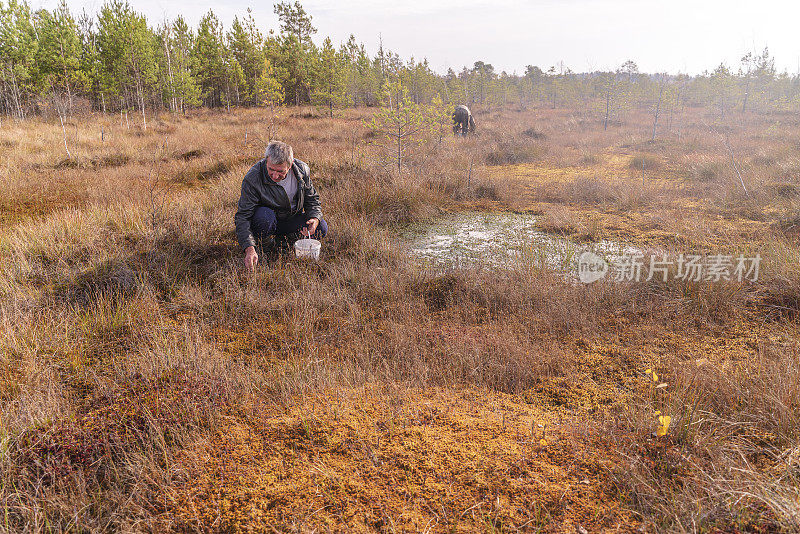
170,387,638,532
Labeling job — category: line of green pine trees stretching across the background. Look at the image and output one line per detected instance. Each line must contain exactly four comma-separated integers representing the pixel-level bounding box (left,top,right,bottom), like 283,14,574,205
0,0,800,127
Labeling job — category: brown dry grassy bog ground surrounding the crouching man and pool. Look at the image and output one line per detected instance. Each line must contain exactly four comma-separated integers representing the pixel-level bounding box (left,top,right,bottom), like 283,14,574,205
0,102,800,532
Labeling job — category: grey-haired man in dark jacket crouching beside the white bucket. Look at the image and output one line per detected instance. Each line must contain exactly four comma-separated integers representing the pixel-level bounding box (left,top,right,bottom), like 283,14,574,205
234,141,328,271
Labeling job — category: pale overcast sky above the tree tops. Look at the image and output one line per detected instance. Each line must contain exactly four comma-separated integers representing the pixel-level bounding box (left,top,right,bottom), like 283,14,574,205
31,0,800,74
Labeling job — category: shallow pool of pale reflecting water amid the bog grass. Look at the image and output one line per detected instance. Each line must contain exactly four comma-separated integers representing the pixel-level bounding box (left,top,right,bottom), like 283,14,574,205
406,212,640,274
